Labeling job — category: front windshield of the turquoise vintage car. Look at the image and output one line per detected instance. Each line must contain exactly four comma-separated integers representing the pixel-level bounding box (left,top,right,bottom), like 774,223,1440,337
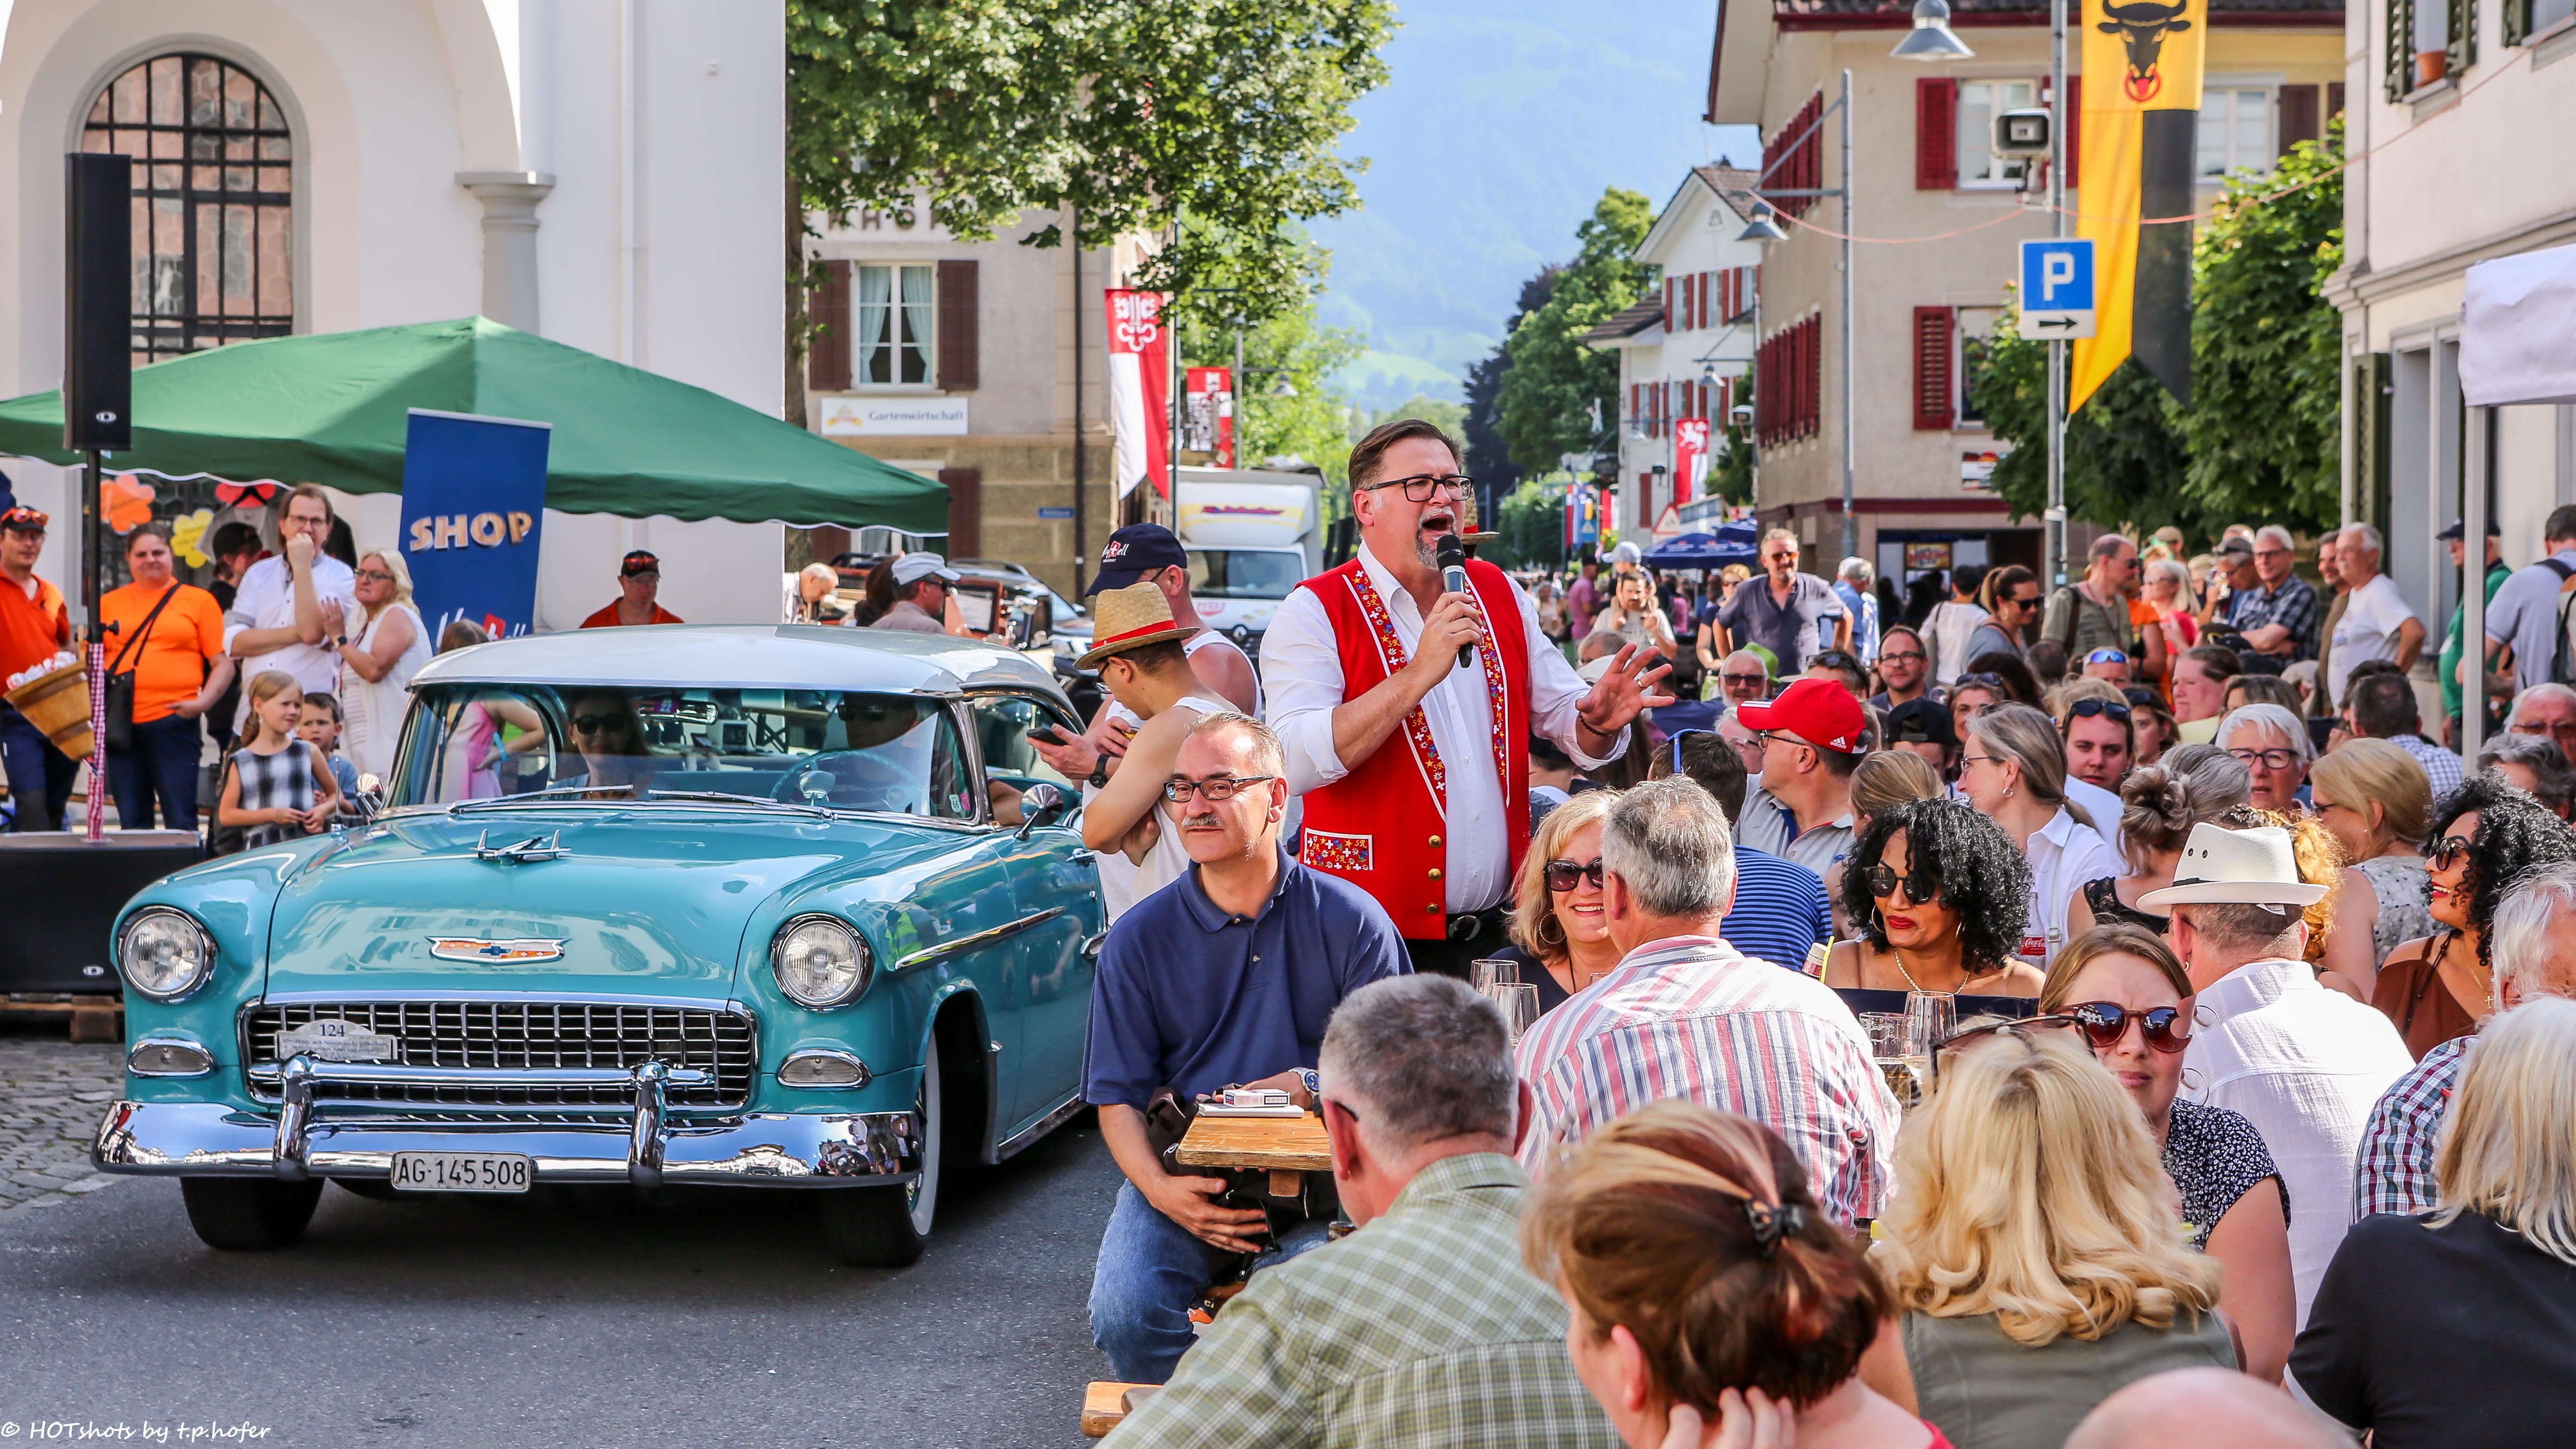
386,684,976,821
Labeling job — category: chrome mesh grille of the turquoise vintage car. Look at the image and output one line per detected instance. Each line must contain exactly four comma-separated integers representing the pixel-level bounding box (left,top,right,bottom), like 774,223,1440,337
242,1001,757,1109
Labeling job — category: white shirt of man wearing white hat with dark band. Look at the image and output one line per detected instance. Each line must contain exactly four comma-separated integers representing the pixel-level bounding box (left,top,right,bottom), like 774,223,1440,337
2182,960,2414,1326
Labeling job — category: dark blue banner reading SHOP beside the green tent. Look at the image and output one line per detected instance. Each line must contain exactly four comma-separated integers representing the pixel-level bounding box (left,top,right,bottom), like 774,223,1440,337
402,407,554,638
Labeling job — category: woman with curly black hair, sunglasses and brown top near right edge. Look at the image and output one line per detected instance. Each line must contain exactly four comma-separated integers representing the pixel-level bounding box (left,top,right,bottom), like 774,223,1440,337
2370,770,2576,1060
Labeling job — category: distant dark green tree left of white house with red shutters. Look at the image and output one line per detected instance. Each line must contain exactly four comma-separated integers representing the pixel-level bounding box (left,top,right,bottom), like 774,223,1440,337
1496,185,1654,473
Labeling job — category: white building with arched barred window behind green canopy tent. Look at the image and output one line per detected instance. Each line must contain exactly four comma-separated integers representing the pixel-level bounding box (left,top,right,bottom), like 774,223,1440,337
0,0,788,628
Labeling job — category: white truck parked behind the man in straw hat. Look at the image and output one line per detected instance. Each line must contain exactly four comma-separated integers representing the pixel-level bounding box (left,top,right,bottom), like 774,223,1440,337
1175,468,1324,656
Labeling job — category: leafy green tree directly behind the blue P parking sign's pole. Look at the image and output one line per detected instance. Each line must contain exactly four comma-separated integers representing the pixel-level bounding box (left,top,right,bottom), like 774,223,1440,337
1971,304,2200,533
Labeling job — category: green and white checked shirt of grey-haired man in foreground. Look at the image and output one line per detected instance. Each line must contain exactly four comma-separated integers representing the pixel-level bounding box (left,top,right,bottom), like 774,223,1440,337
1110,1158,1607,1449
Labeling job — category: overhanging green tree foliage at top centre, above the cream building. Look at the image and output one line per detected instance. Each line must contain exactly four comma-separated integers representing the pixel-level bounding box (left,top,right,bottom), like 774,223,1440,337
786,0,1393,324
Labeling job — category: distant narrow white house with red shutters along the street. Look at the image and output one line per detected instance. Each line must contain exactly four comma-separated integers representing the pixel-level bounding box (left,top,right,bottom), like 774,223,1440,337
1587,165,1762,541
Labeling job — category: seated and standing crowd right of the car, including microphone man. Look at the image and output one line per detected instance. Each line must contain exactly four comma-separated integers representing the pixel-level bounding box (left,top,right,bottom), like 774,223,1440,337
1076,422,2576,1449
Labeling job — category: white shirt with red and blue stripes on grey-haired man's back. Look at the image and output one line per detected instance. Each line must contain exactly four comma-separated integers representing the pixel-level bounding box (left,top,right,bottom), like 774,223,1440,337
1517,937,1896,1223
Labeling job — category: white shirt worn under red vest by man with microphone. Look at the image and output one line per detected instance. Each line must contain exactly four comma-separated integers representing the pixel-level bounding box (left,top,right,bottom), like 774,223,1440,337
1262,543,1628,913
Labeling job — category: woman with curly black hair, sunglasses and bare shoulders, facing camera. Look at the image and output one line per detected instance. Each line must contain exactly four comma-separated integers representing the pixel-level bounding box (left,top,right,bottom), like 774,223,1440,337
1824,800,2045,996
